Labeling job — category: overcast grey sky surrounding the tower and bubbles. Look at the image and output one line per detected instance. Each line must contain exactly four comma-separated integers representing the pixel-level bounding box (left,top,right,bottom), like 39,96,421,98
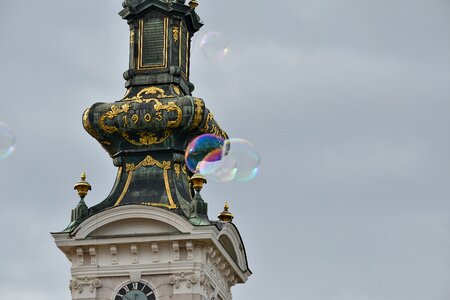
0,0,450,300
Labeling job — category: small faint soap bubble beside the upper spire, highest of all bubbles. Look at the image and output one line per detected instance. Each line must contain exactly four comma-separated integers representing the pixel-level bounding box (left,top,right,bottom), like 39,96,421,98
200,31,230,60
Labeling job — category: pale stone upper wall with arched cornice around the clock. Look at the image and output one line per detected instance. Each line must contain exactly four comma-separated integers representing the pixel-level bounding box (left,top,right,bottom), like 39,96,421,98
54,206,250,300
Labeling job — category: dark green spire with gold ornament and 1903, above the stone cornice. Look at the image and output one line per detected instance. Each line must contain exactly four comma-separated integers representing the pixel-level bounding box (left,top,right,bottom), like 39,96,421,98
83,0,226,225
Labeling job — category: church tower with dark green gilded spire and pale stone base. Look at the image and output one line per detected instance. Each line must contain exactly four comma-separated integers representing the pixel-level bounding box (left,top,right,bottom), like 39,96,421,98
52,0,251,300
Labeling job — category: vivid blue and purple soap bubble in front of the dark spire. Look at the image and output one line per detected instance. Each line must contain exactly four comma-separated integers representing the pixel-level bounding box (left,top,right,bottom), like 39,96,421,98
185,134,224,173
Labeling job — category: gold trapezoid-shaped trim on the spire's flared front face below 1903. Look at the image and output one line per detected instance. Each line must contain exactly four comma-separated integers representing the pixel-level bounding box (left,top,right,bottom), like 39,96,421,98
114,155,177,209
